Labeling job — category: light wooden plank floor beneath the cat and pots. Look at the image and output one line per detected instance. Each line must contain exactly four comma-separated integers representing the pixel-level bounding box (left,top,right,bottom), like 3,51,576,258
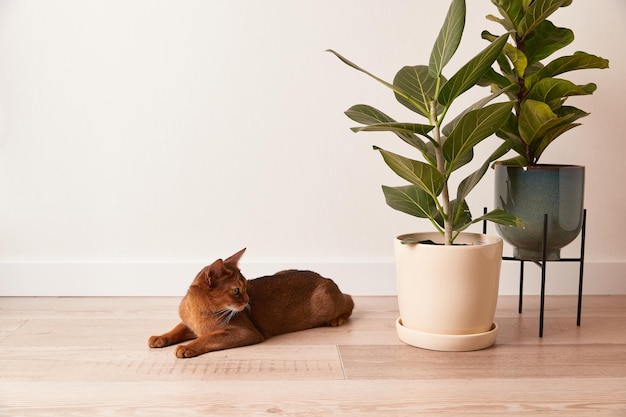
0,296,626,417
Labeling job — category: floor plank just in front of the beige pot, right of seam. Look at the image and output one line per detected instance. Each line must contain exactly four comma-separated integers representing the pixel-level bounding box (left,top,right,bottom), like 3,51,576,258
339,345,626,380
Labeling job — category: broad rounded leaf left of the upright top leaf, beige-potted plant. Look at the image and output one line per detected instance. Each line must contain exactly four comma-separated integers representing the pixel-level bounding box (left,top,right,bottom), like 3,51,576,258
393,65,446,118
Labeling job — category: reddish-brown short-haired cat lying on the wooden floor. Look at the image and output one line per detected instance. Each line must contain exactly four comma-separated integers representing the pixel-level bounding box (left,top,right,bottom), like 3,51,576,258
148,249,354,358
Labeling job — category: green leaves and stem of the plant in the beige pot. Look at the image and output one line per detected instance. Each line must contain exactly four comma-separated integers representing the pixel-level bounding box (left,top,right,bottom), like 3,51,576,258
329,0,521,245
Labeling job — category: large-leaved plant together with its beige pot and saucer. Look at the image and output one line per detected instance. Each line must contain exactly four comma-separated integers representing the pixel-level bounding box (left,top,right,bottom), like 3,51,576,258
329,0,520,350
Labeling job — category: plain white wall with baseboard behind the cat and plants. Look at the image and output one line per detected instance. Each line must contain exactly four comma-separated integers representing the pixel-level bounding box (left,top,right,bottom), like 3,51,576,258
0,0,626,295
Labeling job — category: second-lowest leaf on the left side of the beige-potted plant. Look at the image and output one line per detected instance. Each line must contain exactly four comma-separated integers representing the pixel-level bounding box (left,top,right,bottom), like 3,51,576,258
374,147,444,199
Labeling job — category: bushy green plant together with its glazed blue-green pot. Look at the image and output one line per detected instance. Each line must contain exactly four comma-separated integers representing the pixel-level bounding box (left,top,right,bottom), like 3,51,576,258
481,0,609,260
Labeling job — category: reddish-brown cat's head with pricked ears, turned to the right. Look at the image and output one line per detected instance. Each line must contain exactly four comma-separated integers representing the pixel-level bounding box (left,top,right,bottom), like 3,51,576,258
192,248,250,312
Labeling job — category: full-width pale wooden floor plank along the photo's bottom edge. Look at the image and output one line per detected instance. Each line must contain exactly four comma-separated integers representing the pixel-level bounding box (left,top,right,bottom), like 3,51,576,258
0,378,626,417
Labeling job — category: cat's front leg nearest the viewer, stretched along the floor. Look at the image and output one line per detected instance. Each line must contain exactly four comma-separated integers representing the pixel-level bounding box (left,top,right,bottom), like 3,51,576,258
176,326,263,358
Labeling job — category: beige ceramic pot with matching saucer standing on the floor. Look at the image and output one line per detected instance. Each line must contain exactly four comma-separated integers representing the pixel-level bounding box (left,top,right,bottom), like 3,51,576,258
395,232,502,351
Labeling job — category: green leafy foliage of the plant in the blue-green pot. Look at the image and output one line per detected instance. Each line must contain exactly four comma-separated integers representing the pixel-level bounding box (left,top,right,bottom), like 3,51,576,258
480,0,609,166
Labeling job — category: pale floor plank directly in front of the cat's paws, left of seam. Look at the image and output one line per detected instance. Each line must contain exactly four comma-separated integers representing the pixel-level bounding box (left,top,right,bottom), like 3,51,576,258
0,345,345,382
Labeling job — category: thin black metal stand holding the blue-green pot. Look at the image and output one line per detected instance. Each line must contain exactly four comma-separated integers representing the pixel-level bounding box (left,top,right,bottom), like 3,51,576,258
483,208,587,337
